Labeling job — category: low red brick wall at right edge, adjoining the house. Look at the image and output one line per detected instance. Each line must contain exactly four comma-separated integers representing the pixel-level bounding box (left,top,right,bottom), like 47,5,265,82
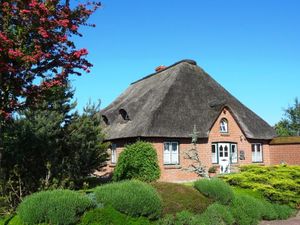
270,144,300,165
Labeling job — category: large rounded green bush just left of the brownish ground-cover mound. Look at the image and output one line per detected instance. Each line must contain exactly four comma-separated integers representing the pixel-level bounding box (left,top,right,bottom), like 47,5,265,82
95,180,162,219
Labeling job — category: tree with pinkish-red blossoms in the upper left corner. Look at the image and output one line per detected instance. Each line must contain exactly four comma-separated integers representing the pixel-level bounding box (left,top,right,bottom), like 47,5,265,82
0,0,100,119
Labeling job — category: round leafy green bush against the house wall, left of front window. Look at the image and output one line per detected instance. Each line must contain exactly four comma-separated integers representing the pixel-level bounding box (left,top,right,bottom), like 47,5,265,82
113,141,160,182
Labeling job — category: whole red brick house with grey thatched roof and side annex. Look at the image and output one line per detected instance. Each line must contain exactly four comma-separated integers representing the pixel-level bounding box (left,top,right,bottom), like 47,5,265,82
100,60,300,181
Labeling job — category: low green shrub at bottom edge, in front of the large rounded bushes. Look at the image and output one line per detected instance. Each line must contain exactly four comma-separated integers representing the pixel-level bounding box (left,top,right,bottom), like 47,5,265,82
79,206,150,225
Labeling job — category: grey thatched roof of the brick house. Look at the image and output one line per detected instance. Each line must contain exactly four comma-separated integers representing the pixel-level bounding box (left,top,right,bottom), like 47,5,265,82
100,60,275,140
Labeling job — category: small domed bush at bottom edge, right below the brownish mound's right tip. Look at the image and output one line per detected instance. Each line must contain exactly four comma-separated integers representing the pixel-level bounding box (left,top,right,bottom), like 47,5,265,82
200,203,235,225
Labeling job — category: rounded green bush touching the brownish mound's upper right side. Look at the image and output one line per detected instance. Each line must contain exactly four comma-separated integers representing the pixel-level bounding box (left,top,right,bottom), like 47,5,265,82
194,178,234,205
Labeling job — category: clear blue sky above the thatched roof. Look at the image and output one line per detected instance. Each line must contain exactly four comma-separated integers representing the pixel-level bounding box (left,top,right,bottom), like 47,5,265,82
71,0,300,125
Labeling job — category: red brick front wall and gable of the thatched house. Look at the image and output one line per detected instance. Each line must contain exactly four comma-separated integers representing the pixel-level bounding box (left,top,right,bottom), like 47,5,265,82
99,108,274,182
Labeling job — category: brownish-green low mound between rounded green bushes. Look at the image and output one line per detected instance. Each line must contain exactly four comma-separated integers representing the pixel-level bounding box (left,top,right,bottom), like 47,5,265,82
152,182,212,215
